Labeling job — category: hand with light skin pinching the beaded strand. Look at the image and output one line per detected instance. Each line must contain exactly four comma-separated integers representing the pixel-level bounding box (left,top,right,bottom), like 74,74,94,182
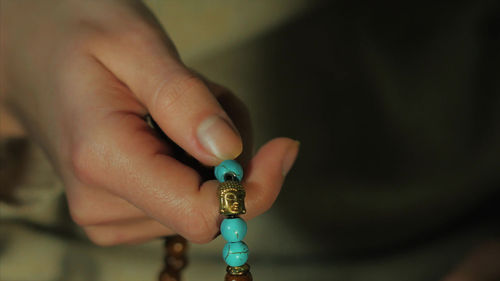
0,0,298,245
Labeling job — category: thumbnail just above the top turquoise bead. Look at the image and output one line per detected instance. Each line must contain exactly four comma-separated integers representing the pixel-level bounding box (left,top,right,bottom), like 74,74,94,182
197,115,243,160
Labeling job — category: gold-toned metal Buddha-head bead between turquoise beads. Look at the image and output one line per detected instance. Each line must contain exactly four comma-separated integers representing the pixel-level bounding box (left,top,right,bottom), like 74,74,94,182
218,181,246,216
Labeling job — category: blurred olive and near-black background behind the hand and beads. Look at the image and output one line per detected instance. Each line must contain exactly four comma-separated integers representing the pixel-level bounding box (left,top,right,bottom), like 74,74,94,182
0,0,500,281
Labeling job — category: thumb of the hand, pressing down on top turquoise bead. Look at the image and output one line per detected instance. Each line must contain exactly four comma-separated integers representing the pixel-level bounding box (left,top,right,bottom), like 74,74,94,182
95,20,243,165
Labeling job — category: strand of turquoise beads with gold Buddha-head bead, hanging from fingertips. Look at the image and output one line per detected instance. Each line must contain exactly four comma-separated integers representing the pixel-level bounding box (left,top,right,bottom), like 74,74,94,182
214,160,253,281
